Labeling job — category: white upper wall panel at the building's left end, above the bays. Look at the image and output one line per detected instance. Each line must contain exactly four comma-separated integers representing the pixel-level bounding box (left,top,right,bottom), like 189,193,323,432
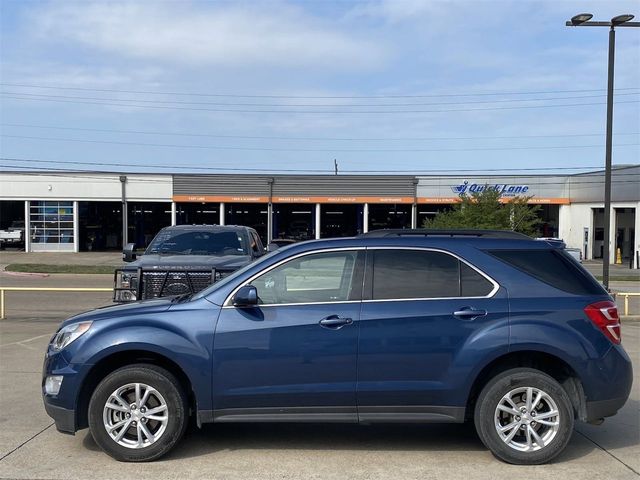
0,173,173,202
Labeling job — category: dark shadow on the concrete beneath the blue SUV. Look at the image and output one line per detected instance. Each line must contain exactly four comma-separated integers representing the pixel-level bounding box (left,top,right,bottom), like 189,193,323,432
83,423,624,463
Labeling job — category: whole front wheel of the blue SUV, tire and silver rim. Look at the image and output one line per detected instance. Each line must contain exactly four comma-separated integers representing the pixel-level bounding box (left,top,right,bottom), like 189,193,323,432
89,364,187,462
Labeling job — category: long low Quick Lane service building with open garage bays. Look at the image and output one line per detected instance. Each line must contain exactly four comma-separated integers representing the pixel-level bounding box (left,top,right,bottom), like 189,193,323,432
0,165,640,268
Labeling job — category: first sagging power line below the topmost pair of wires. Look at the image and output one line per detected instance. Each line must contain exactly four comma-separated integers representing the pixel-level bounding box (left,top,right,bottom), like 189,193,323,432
0,123,640,142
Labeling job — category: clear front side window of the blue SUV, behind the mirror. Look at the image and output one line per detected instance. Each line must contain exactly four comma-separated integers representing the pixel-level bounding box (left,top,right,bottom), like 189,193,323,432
251,251,361,305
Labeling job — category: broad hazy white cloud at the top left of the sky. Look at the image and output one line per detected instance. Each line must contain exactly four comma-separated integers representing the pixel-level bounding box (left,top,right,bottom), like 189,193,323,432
31,2,387,70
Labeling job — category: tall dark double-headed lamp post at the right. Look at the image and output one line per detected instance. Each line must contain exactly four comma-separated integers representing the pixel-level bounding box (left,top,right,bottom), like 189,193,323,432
566,13,640,289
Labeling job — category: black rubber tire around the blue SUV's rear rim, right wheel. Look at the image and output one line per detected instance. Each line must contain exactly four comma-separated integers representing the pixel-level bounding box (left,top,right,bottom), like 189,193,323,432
474,368,574,465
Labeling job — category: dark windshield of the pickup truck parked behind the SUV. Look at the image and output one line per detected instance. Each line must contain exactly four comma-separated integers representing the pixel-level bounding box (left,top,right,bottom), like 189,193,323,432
145,230,249,255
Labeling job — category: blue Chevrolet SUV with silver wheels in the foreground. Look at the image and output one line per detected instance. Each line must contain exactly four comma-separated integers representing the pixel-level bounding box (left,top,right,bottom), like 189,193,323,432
42,230,632,464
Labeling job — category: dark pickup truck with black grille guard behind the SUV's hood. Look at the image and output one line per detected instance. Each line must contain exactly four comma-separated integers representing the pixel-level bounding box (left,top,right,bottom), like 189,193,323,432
113,225,265,303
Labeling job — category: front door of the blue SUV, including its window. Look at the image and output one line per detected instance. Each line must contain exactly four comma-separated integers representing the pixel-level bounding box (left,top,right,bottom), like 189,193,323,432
213,249,365,421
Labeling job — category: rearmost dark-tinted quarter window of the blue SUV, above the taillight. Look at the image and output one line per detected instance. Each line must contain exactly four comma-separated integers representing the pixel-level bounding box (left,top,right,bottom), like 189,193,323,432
488,250,605,295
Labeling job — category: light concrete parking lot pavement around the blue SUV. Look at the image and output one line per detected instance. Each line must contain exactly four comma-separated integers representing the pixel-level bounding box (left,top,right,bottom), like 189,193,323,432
0,273,640,480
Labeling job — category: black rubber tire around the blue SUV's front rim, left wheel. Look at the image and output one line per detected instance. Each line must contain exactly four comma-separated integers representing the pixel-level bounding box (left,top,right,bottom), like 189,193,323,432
89,364,188,462
